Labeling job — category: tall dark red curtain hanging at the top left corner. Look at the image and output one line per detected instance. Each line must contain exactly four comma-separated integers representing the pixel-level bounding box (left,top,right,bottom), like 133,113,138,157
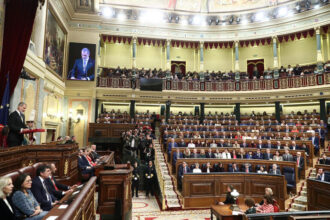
0,0,39,98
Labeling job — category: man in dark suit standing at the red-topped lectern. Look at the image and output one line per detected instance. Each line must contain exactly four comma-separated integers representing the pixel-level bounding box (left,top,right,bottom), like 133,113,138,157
7,102,28,147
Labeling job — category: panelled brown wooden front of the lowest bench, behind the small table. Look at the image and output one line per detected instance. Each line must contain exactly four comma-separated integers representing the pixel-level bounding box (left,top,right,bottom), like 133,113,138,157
182,173,287,210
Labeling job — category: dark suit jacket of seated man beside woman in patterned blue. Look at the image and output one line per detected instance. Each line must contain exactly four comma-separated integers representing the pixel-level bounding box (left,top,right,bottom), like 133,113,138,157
31,176,56,211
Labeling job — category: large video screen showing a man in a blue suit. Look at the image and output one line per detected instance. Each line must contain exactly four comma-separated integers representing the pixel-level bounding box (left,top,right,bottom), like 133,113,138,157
67,43,96,81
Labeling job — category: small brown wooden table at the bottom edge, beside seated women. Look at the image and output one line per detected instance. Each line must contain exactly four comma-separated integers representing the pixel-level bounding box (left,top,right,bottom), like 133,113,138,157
211,204,248,220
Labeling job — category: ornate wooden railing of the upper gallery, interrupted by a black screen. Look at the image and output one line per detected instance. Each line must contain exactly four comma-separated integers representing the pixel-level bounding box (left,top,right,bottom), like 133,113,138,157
97,73,330,92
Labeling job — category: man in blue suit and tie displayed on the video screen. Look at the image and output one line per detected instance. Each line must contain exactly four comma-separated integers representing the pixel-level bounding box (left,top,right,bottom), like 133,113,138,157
68,48,95,81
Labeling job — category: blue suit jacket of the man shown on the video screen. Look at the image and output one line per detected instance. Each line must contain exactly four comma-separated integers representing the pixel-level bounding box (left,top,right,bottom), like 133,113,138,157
68,57,95,81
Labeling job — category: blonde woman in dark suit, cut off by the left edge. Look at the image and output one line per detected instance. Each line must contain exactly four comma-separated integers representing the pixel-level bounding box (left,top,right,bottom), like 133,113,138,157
0,177,18,220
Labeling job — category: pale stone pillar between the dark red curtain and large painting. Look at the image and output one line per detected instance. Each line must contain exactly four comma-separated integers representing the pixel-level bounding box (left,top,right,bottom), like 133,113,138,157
31,1,47,58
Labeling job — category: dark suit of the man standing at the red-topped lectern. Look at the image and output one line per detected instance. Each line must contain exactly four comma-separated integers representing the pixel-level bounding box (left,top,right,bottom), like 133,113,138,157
7,111,27,147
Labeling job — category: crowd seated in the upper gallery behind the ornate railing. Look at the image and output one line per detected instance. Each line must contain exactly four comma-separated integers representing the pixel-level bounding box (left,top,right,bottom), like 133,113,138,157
101,63,330,82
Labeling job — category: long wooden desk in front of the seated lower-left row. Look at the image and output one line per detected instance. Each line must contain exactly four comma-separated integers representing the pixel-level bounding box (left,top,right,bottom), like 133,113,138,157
43,177,96,220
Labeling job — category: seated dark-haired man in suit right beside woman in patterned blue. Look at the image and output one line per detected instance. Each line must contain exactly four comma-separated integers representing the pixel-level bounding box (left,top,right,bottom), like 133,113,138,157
31,164,58,211
